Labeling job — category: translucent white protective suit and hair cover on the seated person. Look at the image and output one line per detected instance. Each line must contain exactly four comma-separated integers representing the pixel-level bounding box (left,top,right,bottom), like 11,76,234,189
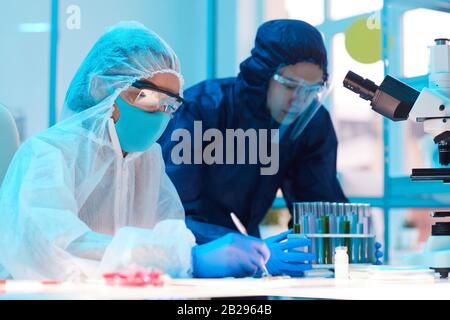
0,22,195,281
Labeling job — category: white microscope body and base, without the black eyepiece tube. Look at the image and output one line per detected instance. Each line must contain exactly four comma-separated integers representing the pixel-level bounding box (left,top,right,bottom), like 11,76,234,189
400,39,450,278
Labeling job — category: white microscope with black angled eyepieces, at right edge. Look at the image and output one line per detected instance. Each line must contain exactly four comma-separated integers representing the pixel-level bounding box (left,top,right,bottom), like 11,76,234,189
343,38,450,278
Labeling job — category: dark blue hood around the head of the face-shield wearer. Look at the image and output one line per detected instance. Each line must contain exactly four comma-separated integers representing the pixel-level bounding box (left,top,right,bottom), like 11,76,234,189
236,20,328,118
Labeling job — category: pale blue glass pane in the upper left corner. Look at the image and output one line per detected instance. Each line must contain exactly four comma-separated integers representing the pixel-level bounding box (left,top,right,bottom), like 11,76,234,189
0,0,50,141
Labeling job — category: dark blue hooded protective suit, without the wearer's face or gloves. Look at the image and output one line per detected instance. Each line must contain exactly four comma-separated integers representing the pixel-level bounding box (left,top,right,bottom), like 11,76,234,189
159,20,347,243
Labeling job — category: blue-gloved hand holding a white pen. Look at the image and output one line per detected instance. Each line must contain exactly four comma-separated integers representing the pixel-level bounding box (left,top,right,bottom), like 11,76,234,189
192,233,270,278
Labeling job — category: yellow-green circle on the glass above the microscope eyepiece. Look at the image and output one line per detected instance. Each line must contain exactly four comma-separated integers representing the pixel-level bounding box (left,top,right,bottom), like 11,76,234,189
345,18,381,64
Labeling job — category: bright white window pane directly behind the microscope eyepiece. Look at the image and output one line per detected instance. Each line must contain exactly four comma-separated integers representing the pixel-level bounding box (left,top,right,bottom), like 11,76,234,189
331,33,383,196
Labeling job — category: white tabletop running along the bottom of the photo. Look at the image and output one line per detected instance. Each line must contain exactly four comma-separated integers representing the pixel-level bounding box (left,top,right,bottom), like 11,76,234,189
0,278,450,300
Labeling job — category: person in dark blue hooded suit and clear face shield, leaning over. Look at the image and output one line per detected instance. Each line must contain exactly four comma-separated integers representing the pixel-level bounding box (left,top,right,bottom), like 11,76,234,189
159,20,347,276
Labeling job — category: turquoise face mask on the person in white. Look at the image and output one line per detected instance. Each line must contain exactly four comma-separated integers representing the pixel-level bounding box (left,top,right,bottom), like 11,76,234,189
116,96,170,152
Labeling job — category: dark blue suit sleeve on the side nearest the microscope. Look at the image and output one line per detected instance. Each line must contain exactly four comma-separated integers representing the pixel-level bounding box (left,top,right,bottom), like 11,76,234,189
282,107,348,218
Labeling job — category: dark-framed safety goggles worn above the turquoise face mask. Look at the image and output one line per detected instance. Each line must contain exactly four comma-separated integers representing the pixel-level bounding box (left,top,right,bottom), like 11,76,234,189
123,81,185,114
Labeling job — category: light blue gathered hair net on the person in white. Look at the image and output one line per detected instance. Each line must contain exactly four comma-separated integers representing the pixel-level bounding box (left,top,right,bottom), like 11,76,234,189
61,22,183,119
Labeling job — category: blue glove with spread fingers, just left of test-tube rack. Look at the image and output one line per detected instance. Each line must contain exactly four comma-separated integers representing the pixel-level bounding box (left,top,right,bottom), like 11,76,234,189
265,229,316,277
